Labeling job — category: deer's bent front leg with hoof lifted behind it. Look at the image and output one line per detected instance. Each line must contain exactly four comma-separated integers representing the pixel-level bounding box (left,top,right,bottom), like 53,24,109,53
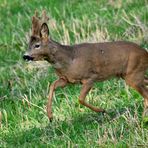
79,82,105,112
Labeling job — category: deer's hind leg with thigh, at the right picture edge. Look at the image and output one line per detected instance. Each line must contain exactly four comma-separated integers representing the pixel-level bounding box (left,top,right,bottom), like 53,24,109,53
125,72,148,117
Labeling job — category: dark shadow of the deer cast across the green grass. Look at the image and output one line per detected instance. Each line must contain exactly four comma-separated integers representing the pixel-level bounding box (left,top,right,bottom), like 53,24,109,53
4,108,143,146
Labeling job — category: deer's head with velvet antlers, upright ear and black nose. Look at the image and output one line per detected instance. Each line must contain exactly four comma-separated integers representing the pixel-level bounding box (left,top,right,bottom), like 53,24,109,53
23,10,54,61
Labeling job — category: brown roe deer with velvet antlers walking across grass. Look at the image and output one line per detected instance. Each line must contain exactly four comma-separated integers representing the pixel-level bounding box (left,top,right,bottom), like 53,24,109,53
23,11,148,119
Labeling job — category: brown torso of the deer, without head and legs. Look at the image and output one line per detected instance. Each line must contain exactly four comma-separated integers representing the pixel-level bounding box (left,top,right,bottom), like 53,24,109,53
51,41,148,83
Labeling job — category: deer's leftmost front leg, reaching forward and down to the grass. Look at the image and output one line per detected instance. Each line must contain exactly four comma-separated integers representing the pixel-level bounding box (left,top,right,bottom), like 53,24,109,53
47,78,67,119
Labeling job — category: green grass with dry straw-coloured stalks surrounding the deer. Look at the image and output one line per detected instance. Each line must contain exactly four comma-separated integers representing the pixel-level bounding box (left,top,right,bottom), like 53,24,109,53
0,0,148,147
